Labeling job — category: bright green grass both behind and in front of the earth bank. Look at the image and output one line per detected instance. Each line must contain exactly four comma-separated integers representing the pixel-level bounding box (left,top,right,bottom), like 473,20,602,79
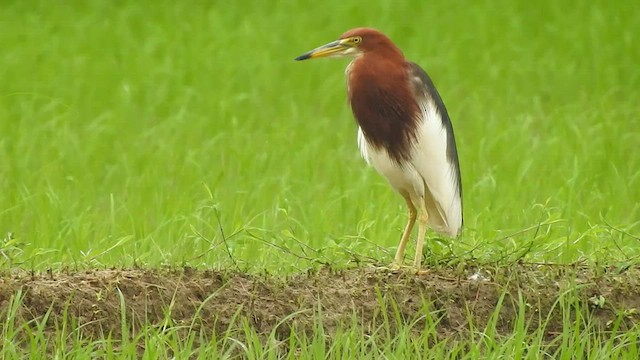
0,0,640,359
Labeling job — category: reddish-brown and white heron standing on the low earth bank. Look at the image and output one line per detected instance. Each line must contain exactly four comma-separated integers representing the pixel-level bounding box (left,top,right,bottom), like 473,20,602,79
295,27,463,270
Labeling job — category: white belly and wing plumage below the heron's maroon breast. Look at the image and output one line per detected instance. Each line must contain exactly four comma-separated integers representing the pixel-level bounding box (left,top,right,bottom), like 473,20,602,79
358,102,462,237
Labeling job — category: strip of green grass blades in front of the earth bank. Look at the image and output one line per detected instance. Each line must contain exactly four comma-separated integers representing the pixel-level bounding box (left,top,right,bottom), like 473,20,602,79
0,290,640,359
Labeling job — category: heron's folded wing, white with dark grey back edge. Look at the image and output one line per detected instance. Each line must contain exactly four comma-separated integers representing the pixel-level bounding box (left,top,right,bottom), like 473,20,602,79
409,63,463,237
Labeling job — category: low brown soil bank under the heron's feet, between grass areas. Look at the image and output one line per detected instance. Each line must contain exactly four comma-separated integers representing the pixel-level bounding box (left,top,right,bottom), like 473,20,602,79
0,264,640,346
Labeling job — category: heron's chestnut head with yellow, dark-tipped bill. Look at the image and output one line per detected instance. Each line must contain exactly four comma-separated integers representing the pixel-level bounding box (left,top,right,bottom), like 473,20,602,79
295,28,402,60
